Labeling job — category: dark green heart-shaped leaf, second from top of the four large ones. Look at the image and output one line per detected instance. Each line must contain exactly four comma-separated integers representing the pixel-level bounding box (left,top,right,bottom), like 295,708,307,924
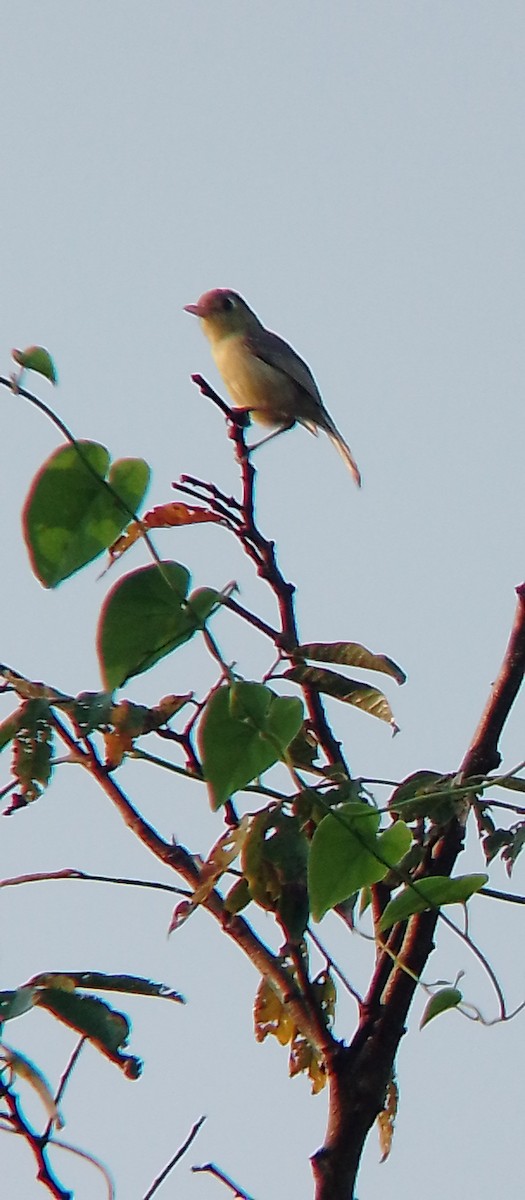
97,562,221,690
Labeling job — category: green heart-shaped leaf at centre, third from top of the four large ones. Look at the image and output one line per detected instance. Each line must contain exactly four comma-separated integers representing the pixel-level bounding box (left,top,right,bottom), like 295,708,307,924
198,683,303,810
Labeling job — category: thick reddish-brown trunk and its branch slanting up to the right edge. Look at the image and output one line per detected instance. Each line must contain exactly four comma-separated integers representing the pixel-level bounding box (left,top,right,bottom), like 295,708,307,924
313,584,525,1200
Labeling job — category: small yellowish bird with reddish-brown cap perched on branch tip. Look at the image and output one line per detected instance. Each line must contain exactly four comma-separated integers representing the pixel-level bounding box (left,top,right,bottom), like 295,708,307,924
185,288,361,487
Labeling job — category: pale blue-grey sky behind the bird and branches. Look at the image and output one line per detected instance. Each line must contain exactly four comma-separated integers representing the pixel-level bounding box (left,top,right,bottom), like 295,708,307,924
0,7,525,1200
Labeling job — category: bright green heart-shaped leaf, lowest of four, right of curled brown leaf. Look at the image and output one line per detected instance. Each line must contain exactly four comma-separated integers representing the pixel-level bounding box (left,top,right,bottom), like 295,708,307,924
308,803,412,920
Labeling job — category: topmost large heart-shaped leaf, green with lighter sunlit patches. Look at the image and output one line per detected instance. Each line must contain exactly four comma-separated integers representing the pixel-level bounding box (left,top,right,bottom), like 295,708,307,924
23,442,150,588
